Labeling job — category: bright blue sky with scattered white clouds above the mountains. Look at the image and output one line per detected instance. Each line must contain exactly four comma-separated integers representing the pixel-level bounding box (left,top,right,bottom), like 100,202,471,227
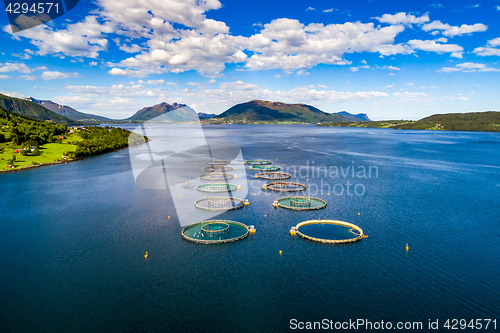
0,0,500,120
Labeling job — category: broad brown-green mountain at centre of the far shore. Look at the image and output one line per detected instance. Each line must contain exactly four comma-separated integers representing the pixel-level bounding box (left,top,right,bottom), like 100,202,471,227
211,100,345,123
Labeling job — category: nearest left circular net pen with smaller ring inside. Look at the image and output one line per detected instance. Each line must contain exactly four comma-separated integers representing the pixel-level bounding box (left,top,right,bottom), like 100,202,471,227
182,220,249,244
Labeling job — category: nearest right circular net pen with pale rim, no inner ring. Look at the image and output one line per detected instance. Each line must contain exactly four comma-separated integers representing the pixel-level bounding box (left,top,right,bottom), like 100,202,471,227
296,220,365,244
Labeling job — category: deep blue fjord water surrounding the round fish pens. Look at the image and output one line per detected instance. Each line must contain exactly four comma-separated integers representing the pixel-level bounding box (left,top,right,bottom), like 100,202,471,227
0,125,500,332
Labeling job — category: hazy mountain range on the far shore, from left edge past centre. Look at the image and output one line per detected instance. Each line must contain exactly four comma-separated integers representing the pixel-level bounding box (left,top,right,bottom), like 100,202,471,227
0,94,370,125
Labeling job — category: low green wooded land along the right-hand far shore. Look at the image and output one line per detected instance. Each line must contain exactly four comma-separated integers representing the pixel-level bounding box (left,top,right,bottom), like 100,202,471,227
317,111,500,132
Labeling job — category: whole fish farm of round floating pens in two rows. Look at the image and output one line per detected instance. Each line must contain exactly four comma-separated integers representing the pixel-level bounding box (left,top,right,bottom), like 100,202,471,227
182,159,368,246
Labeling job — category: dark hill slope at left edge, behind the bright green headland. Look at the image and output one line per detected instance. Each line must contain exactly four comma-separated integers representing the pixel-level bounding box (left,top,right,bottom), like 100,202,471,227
0,94,75,125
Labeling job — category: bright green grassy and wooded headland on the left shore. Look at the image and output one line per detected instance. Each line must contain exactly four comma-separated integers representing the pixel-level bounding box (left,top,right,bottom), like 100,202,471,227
0,107,147,172
